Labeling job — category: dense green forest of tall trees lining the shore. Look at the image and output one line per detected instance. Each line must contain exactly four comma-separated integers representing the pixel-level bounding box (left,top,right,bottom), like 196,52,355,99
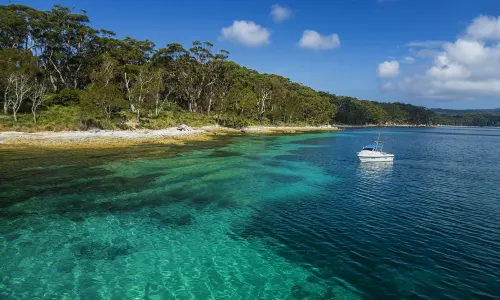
0,5,500,130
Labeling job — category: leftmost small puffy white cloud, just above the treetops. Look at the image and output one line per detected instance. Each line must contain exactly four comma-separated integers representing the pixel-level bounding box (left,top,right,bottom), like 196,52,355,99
220,21,271,47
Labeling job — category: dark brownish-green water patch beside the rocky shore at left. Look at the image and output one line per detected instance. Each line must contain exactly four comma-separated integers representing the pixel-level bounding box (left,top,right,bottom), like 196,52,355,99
0,136,239,221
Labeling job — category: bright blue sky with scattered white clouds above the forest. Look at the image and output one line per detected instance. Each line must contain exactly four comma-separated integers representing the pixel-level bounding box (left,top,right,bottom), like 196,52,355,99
0,0,500,108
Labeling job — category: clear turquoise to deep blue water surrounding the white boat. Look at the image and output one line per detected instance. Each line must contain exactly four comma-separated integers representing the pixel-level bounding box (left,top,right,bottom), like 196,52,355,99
0,128,500,299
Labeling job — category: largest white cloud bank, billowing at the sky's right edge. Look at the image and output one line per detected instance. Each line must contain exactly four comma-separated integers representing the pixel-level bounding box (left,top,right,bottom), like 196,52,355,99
379,16,500,99
